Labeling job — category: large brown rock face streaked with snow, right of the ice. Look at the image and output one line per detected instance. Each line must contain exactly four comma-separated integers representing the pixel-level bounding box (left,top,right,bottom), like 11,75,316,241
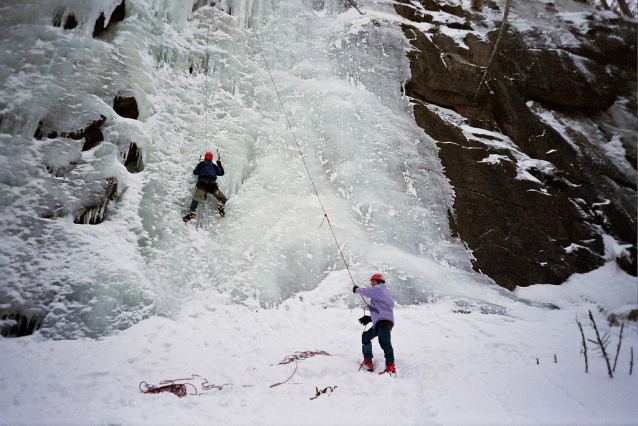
396,0,638,290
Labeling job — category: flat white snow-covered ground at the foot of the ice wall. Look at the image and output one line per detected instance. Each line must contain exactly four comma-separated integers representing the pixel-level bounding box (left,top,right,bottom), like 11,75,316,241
0,263,638,425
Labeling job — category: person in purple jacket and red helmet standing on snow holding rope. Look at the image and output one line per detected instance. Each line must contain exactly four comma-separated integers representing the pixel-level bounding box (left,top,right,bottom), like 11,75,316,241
352,274,396,374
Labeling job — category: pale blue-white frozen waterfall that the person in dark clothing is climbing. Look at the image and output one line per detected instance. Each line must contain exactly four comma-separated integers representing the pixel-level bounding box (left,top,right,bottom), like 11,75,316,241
0,0,502,338
